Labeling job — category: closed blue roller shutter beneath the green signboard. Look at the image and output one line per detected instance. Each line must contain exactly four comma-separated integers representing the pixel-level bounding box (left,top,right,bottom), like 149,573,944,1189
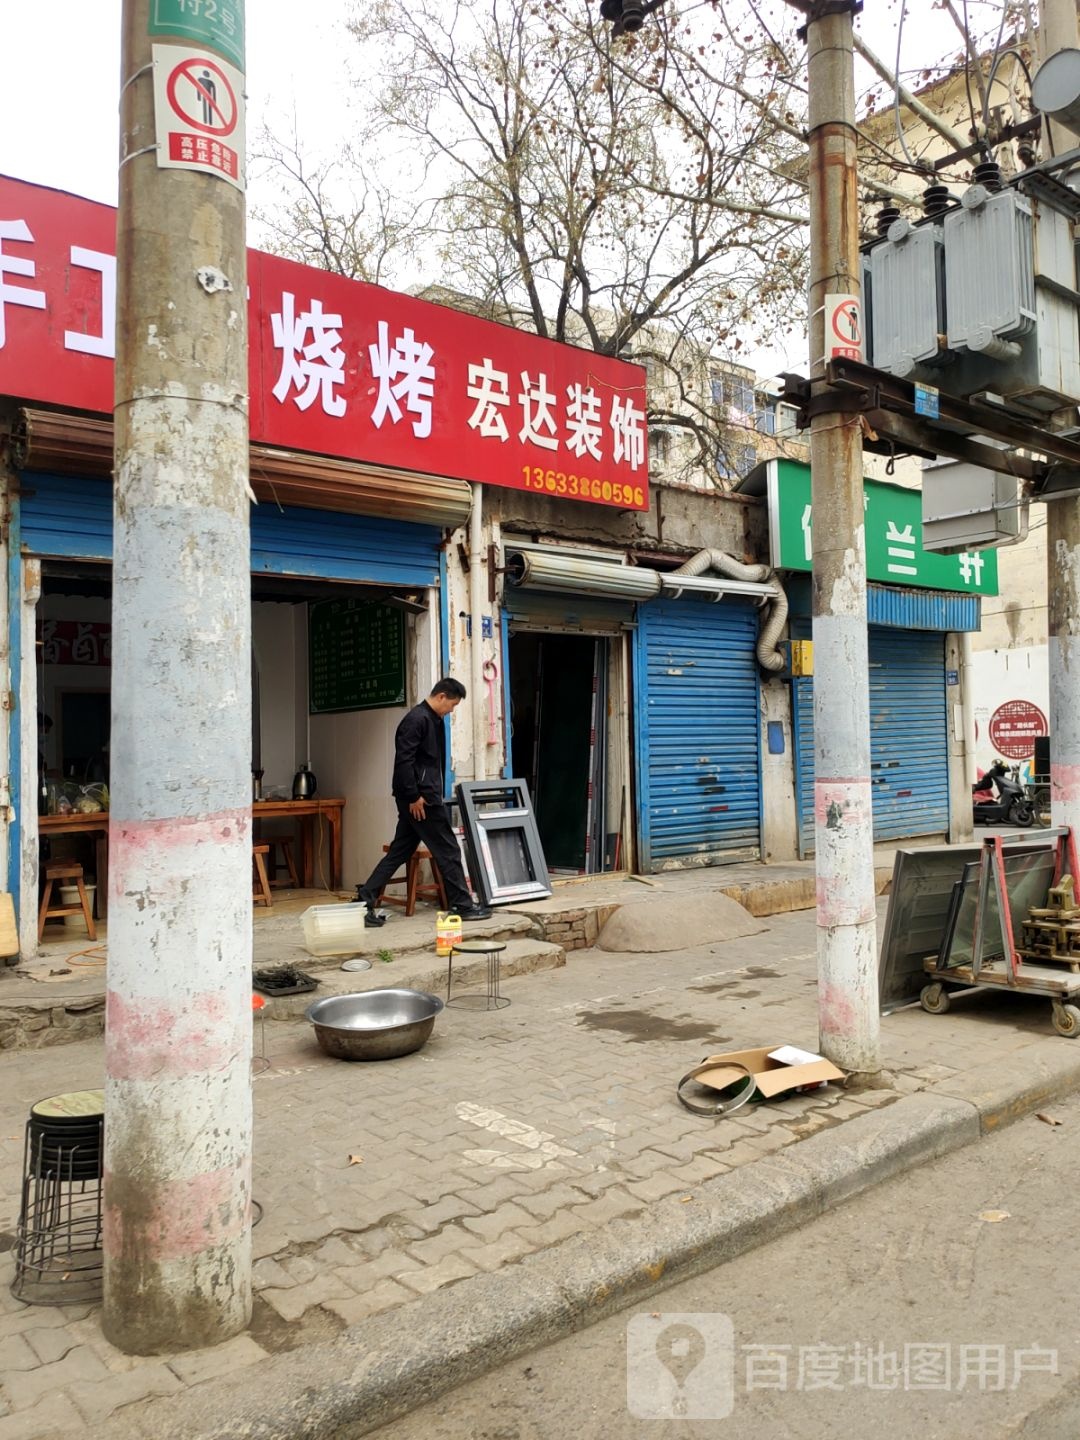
792,621,949,855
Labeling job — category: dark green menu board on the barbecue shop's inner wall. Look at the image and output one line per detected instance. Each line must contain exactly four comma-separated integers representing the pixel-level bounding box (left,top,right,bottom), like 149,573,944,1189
308,599,405,714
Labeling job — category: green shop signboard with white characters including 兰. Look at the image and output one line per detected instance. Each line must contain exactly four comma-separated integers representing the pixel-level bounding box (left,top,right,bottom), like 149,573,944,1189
769,459,998,595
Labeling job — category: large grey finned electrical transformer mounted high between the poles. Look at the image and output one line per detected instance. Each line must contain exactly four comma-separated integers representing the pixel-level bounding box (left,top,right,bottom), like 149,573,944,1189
864,166,1080,416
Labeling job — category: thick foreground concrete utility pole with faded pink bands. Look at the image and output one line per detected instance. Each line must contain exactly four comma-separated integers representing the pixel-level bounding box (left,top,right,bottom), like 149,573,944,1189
104,0,252,1354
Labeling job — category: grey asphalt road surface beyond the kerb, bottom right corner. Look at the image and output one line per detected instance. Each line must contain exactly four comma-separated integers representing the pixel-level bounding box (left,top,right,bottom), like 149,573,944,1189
377,1097,1080,1440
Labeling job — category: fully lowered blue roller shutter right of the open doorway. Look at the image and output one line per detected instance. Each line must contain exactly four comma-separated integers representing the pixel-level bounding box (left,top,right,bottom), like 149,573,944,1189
634,600,762,871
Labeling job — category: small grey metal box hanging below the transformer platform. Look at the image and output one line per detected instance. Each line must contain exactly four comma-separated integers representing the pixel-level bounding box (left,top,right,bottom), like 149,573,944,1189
923,461,1027,554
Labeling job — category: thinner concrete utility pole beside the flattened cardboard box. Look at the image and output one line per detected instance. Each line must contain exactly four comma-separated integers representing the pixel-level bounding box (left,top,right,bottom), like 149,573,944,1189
799,0,881,1076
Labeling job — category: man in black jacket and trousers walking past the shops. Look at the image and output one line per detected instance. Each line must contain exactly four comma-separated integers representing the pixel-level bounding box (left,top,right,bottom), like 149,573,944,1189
356,678,491,924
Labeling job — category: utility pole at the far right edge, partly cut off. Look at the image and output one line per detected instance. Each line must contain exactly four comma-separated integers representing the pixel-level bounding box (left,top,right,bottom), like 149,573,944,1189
1038,0,1080,834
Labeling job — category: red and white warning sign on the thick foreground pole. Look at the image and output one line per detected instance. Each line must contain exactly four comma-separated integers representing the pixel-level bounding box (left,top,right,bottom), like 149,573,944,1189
151,45,245,190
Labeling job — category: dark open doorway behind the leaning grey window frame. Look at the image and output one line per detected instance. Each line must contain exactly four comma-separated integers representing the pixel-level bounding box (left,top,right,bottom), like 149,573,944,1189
510,631,609,874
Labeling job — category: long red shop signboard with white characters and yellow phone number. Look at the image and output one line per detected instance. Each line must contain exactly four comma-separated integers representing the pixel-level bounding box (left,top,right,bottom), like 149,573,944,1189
0,176,648,510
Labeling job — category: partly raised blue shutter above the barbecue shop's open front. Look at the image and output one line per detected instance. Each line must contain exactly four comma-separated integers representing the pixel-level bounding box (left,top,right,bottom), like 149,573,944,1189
20,474,442,588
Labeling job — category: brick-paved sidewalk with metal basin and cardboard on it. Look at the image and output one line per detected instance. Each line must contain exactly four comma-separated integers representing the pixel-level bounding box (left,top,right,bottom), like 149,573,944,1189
0,912,1067,1440
